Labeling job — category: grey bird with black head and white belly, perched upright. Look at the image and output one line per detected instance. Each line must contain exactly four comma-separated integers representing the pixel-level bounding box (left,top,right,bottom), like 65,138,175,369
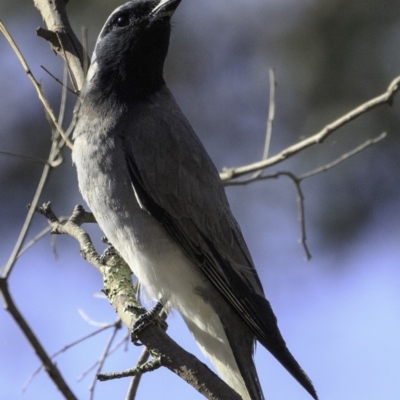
72,0,317,400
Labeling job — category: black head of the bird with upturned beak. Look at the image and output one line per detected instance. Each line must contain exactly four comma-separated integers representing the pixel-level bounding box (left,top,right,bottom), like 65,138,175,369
84,0,181,98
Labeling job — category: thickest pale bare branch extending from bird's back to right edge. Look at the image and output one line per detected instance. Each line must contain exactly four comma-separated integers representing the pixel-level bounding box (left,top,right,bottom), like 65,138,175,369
220,76,400,181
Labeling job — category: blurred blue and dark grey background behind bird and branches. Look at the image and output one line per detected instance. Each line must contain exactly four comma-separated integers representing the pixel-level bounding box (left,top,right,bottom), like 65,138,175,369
0,0,400,400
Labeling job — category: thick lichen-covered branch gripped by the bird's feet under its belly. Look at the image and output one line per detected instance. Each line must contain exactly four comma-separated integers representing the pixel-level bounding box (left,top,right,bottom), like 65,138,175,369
36,203,239,400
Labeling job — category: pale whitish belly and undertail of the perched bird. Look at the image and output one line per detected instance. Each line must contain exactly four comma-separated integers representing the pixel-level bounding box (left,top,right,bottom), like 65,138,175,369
74,140,249,399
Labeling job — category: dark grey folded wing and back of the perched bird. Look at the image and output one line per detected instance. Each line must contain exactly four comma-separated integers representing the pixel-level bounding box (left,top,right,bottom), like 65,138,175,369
120,89,315,400
